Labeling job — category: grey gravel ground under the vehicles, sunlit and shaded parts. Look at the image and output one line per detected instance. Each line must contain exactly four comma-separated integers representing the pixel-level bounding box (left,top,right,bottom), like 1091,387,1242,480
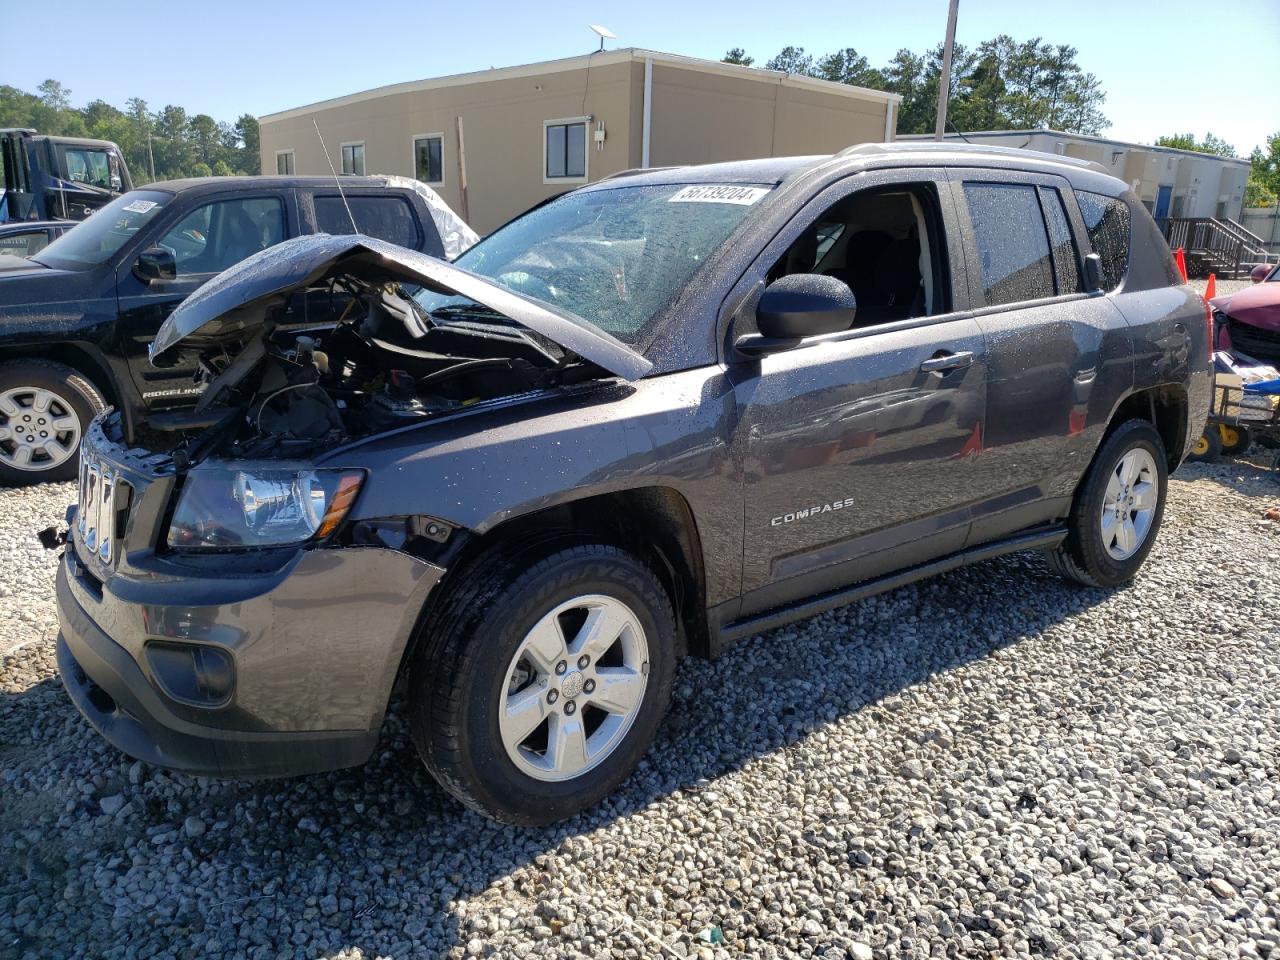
0,457,1280,960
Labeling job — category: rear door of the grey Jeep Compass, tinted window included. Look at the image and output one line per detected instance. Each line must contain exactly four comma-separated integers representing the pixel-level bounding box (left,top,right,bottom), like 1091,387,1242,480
951,169,1133,543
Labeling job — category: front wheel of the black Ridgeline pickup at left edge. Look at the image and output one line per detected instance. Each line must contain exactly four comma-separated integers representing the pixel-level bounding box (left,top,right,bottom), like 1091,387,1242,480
0,360,105,486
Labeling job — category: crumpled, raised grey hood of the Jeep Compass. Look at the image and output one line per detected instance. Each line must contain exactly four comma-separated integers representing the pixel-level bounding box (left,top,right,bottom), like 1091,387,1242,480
151,233,653,380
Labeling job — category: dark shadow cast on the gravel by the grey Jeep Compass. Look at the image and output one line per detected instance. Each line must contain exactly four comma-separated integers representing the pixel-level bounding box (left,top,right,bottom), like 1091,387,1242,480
0,547,1110,959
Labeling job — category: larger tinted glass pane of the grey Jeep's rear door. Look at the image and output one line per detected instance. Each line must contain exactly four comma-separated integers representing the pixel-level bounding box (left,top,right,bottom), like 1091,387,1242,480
964,183,1053,305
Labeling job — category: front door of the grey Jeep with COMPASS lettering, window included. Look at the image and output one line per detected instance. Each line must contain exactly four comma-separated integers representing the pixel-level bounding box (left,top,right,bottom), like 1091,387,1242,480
733,170,986,614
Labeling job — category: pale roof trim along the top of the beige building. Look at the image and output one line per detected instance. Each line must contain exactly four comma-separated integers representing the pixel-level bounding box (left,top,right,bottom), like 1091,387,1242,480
259,47,902,123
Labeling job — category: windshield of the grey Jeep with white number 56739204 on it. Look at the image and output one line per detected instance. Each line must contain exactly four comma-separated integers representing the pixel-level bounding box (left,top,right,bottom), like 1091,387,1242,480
415,183,771,346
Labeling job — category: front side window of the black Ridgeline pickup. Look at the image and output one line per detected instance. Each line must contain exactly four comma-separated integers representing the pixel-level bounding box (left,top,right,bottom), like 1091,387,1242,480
160,197,284,276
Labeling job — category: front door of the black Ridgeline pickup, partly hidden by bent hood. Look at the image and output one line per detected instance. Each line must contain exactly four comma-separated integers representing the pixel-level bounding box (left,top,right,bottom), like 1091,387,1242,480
115,188,296,410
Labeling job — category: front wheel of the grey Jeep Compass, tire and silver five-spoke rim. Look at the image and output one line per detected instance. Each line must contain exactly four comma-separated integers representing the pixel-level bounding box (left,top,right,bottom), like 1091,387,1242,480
410,543,676,824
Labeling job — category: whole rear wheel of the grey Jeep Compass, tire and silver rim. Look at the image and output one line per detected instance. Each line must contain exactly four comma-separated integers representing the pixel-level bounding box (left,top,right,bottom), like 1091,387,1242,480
1048,420,1169,588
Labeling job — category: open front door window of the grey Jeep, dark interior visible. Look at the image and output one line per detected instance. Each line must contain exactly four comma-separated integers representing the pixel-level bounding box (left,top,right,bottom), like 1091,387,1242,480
768,184,951,328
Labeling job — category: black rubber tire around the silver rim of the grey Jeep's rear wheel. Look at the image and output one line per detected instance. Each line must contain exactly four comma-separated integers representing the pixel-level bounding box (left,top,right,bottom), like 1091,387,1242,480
1069,420,1169,586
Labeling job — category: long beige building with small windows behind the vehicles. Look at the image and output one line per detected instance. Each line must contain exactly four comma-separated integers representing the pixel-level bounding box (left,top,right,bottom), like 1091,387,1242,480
261,49,901,233
